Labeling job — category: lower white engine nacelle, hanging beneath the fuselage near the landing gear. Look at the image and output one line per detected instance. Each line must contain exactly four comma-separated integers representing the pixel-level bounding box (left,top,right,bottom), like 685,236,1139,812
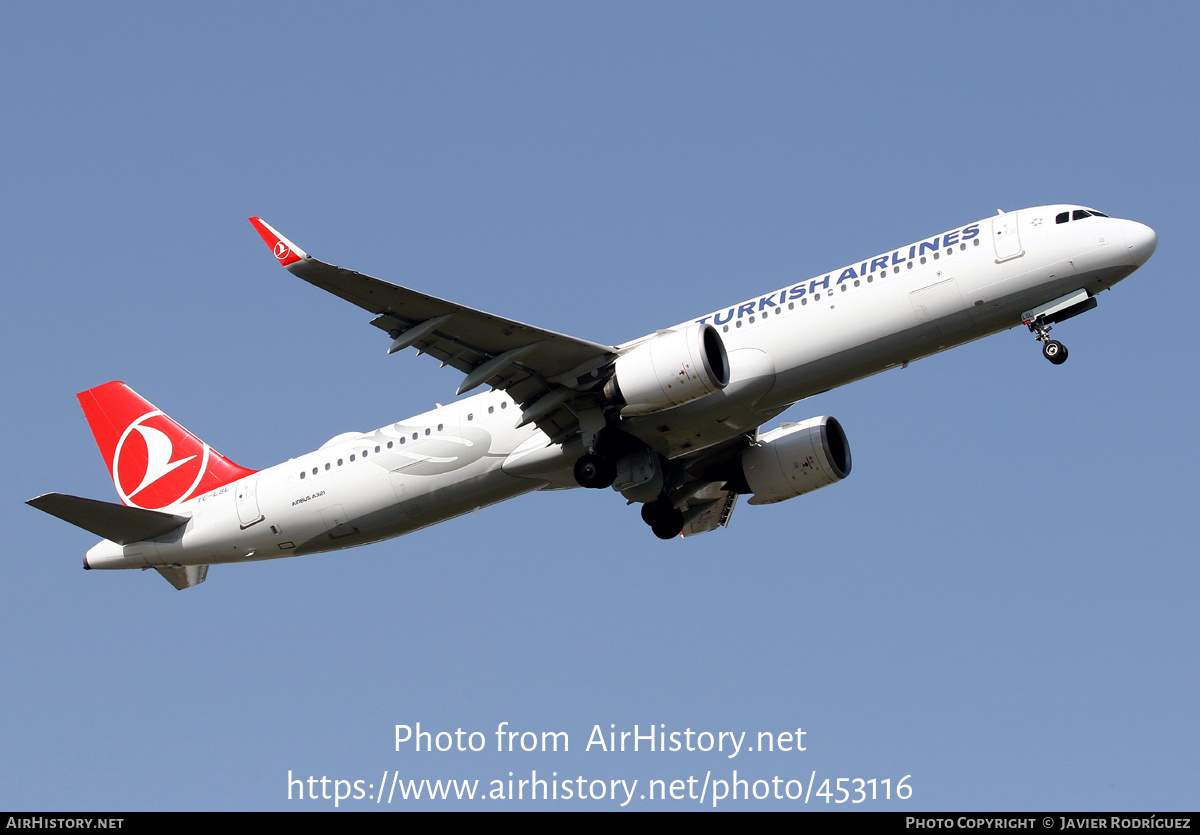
742,416,850,504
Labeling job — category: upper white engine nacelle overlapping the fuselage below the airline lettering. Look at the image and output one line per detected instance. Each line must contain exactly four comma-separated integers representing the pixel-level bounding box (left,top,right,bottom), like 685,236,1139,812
604,324,730,415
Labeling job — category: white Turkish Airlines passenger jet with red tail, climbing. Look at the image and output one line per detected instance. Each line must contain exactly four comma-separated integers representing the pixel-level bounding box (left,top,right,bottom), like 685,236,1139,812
28,204,1158,589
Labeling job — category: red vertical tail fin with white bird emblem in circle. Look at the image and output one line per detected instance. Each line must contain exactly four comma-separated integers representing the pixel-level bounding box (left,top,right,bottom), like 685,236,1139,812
78,380,254,510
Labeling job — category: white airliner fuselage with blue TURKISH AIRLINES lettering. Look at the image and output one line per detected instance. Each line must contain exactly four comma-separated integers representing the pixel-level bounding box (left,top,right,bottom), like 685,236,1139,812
86,205,1156,569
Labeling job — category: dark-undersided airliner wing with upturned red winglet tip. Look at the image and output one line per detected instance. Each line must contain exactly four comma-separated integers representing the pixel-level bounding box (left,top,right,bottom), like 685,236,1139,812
250,217,617,443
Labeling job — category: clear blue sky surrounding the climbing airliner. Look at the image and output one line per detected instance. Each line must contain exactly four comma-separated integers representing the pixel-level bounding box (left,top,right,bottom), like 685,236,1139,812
0,2,1200,811
